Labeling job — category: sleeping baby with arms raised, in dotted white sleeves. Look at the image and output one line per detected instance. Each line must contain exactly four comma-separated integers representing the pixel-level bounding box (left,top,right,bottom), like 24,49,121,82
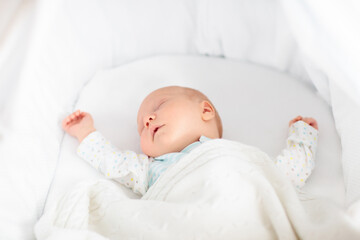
62,86,318,195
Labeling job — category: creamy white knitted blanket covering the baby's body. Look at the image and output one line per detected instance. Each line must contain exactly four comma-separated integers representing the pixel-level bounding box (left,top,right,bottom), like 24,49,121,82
35,139,360,240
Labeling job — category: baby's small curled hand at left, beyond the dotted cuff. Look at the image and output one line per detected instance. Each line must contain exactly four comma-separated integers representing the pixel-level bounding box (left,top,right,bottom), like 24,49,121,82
62,110,96,142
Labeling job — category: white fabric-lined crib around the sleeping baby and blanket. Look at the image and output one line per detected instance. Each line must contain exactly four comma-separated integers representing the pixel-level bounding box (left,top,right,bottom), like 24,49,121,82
0,0,360,239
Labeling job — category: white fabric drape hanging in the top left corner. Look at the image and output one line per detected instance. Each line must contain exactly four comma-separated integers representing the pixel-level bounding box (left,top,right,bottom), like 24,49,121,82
0,0,35,116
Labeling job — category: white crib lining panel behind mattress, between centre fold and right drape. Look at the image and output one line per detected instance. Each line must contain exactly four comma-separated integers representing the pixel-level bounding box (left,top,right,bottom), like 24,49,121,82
196,0,311,82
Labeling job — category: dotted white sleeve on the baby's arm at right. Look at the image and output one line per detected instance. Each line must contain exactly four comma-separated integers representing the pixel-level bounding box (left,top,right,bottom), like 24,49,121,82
275,121,318,188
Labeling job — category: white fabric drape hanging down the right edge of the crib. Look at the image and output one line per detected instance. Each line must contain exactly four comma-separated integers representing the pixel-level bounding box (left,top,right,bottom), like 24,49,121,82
280,0,360,204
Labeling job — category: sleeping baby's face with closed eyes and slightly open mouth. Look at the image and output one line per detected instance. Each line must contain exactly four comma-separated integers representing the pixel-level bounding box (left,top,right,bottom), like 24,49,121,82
137,89,202,157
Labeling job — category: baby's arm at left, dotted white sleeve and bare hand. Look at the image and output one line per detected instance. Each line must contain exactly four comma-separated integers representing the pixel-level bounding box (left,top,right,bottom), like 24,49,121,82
63,110,149,195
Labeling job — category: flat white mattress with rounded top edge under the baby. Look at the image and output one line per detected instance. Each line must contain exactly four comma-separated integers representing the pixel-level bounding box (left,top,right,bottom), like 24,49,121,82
45,56,345,211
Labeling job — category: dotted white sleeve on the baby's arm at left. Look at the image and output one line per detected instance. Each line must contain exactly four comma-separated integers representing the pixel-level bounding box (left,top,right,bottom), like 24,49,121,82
77,131,150,195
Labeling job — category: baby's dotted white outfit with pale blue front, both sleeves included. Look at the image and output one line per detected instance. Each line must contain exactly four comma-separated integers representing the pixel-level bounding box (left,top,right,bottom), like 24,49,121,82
77,121,318,195
